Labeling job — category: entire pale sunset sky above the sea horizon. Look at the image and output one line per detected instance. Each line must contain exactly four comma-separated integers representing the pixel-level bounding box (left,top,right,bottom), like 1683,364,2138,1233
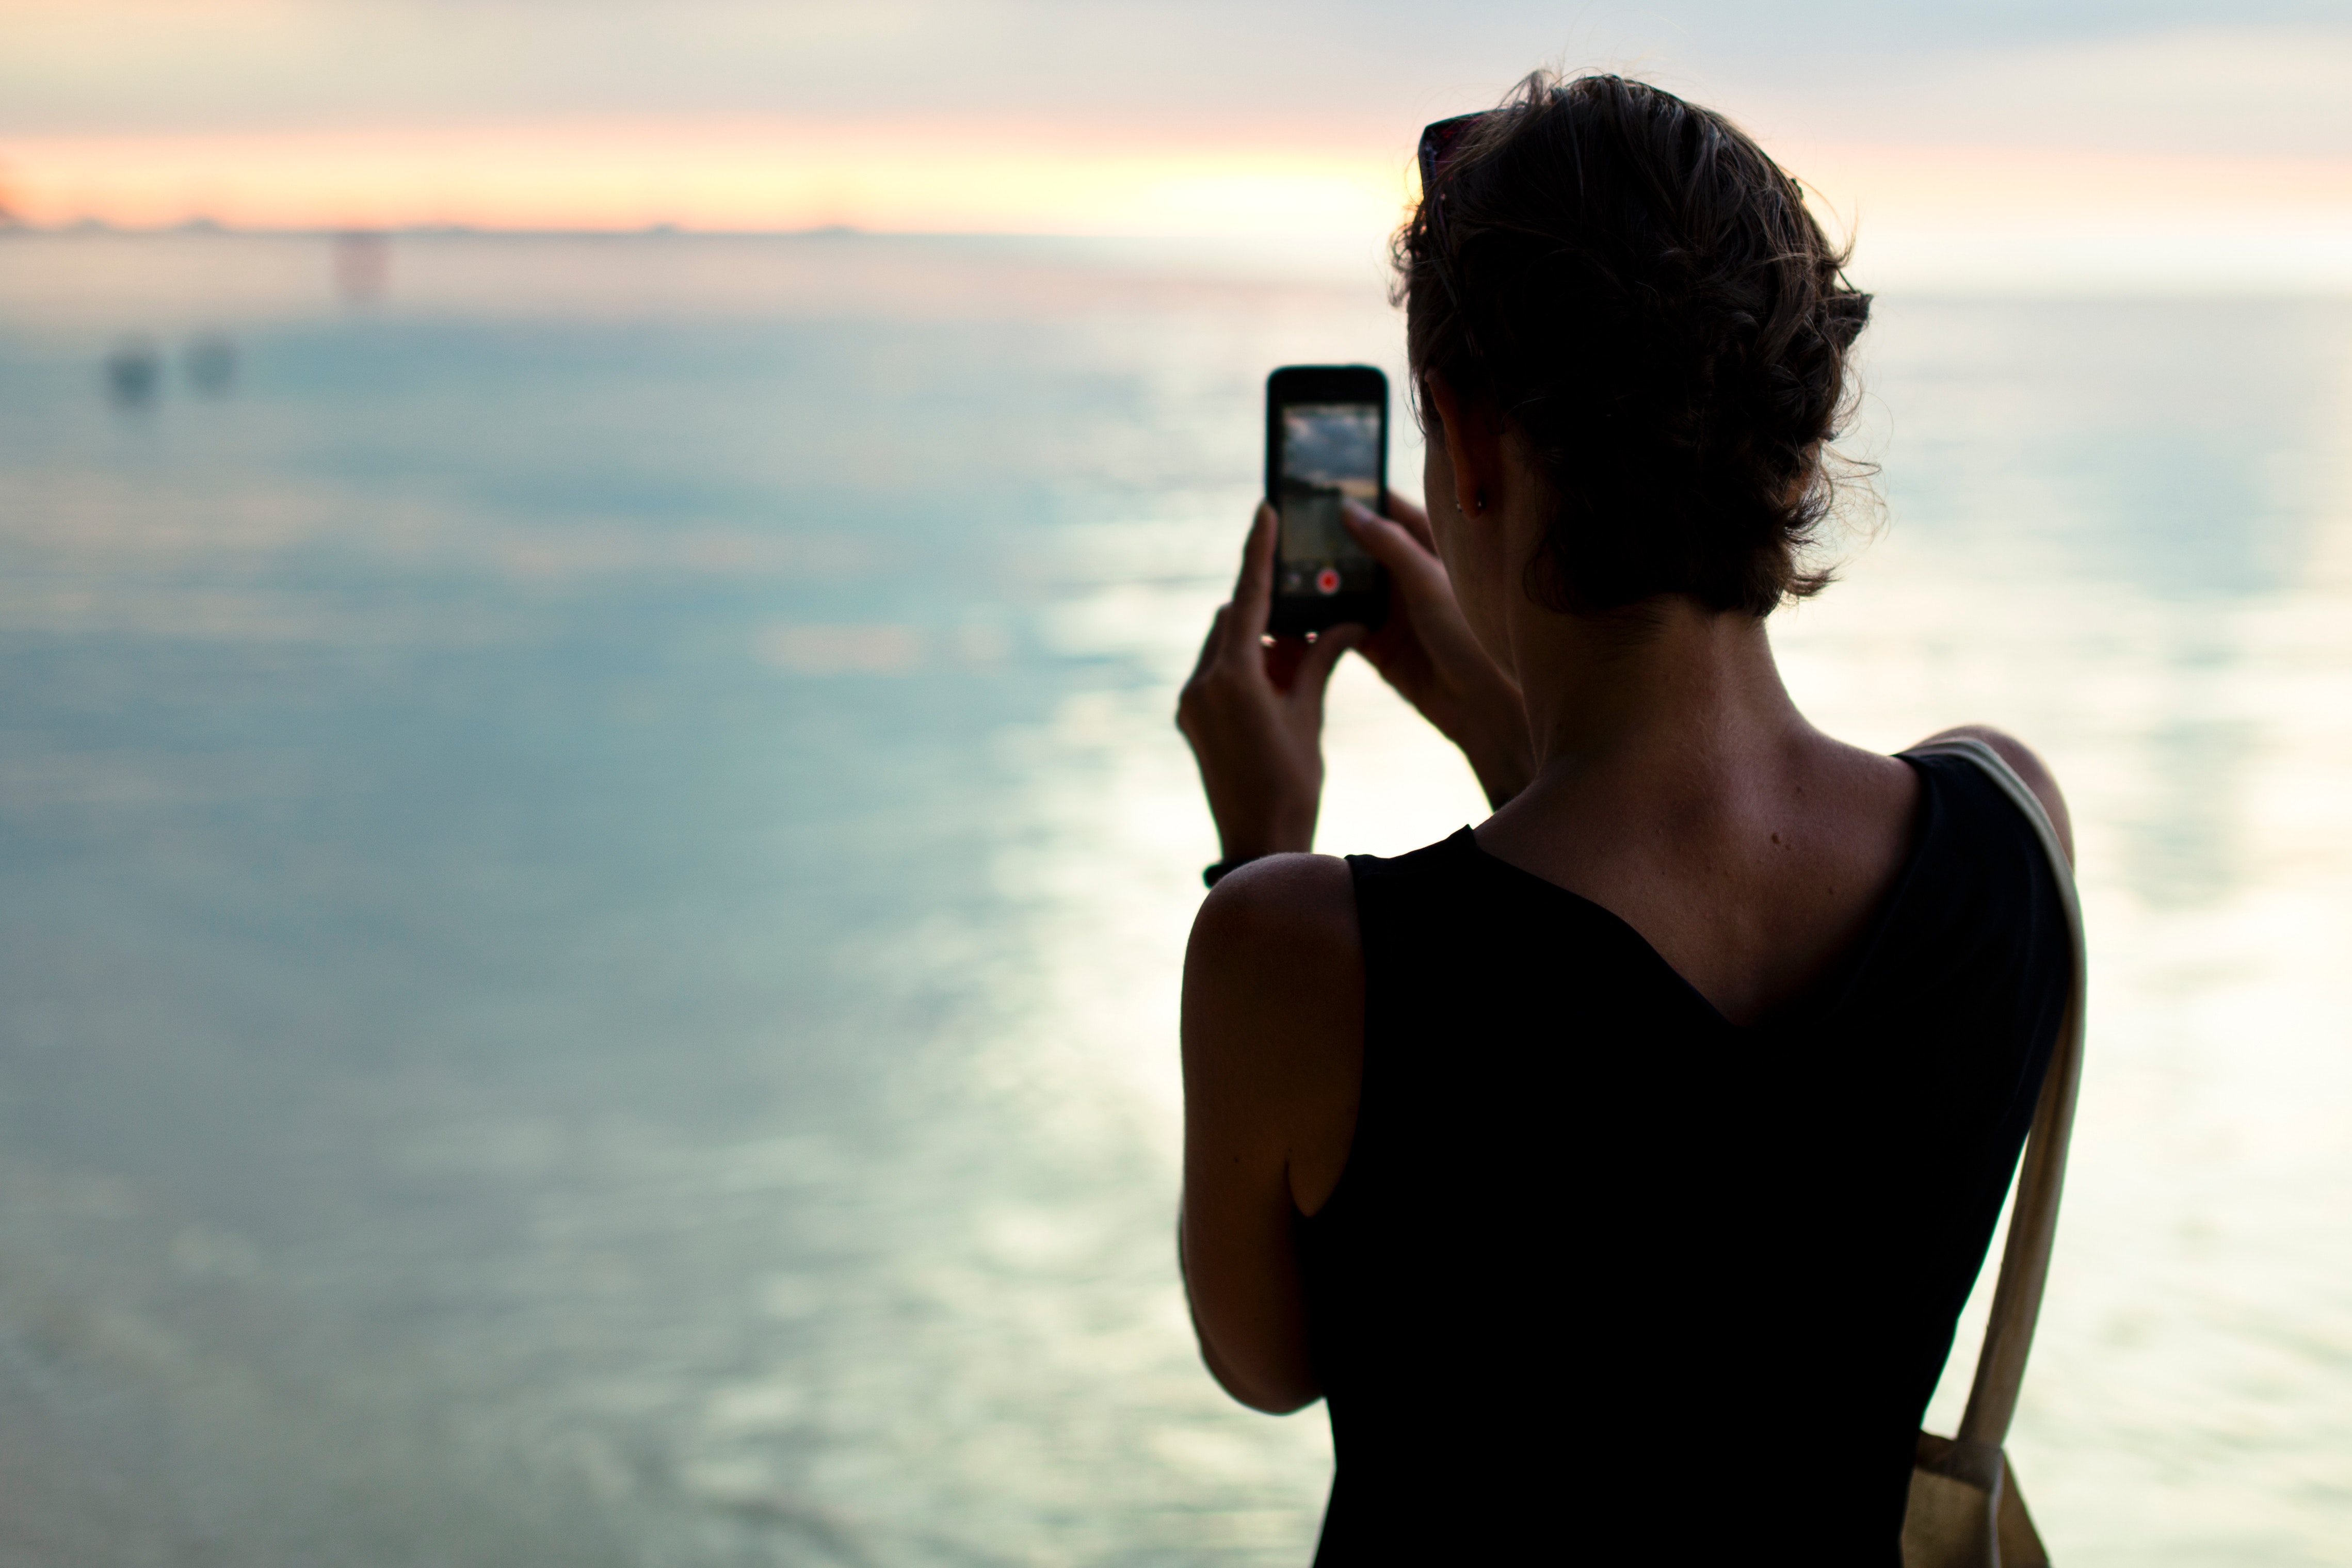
0,0,2352,289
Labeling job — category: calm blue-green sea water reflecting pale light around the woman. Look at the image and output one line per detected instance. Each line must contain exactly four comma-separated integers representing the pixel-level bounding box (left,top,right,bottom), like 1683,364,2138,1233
0,237,2352,1568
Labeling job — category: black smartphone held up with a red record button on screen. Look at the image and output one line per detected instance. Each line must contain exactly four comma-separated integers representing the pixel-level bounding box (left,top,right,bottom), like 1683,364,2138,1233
1265,364,1388,637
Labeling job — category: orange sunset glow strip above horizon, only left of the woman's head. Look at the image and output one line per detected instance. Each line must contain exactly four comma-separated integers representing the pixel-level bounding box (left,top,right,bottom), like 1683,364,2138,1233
9,122,1407,235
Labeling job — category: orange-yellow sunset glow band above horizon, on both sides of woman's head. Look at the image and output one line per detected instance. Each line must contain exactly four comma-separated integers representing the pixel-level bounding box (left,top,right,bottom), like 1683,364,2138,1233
0,120,2352,297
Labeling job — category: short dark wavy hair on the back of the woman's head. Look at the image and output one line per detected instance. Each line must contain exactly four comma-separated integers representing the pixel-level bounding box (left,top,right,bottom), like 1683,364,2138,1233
1392,71,1870,616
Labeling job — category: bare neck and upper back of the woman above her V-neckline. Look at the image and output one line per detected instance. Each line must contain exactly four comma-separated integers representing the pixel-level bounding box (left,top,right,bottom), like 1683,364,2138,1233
1477,600,1919,1023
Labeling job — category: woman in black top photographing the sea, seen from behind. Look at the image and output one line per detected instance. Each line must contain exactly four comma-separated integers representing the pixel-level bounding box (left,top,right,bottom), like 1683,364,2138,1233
1179,75,2070,1563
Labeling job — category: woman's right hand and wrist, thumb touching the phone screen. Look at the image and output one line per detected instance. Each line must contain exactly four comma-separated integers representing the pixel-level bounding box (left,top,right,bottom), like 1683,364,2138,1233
1343,491,1536,806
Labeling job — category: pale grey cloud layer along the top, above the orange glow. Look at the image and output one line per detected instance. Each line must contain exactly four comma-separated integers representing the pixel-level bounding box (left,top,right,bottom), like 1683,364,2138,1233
0,0,2352,153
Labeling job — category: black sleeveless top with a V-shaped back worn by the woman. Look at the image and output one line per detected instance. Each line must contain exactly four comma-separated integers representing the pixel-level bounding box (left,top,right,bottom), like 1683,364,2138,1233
1298,757,2070,1568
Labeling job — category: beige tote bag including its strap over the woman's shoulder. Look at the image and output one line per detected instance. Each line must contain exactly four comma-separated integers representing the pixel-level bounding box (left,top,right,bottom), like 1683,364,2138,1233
1903,738,2086,1568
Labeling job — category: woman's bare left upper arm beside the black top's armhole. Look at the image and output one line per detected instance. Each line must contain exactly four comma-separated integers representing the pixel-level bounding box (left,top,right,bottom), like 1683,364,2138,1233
1181,855,1364,1411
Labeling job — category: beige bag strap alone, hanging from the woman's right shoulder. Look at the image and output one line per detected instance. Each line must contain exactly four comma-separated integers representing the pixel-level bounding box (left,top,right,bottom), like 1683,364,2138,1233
1905,738,2089,1448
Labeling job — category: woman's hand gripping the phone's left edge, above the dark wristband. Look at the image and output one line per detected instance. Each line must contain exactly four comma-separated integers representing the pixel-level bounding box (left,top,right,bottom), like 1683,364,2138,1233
1176,506,1364,861
